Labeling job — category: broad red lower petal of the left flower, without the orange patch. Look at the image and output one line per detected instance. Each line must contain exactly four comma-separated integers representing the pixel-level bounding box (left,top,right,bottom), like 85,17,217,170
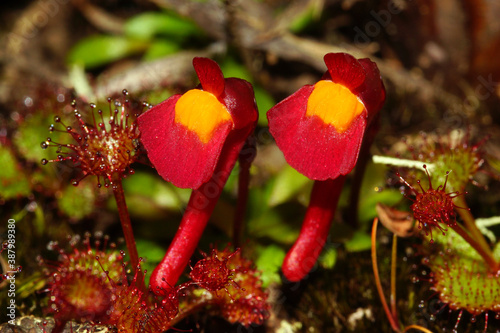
137,95,232,189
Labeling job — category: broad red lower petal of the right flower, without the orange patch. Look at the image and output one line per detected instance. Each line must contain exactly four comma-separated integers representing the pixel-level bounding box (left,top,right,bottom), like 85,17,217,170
267,85,366,180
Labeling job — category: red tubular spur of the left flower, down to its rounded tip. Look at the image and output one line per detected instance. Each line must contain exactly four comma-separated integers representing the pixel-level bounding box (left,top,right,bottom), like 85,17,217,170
150,129,248,294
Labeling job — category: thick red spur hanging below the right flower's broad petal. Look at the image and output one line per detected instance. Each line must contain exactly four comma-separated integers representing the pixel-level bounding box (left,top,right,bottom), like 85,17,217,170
283,176,346,282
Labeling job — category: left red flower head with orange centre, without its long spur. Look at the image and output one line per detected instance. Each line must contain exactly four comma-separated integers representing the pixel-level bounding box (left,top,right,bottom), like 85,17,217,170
138,57,258,189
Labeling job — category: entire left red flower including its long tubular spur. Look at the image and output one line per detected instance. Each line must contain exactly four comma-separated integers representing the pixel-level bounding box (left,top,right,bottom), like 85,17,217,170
138,57,258,291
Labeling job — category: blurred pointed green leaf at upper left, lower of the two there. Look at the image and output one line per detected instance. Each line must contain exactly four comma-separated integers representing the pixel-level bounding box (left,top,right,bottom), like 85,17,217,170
68,35,149,68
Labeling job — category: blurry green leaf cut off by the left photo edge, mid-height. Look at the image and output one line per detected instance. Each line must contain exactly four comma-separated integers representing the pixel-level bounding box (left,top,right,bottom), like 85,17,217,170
0,145,31,200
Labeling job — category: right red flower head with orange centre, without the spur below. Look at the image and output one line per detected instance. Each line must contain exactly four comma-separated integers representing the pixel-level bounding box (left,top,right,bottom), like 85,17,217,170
267,53,385,180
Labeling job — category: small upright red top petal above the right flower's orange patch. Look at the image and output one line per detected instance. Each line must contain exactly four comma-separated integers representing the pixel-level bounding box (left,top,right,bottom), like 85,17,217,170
324,53,365,91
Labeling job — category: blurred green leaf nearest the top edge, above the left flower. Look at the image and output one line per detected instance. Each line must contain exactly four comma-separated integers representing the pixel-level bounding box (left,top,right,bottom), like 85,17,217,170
125,12,203,41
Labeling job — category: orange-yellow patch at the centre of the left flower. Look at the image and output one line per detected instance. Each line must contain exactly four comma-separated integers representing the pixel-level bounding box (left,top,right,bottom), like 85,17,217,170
175,89,232,143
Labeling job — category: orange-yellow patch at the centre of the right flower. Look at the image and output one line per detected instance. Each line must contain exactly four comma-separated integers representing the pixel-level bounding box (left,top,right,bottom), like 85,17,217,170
306,80,365,133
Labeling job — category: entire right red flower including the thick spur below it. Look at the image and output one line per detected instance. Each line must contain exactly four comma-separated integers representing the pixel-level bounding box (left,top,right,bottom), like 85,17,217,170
267,53,385,281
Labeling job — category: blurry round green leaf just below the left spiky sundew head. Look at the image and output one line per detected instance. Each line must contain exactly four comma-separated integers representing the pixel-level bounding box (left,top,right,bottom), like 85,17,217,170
57,180,97,220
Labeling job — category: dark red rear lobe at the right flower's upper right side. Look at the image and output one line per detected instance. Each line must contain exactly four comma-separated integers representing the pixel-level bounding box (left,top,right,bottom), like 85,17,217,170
354,58,385,120
